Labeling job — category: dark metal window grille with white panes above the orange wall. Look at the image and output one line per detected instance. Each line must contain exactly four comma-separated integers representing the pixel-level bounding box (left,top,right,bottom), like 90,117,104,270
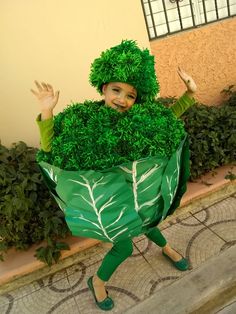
141,0,236,40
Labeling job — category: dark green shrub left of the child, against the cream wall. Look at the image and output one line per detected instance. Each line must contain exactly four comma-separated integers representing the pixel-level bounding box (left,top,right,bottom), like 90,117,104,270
0,142,69,265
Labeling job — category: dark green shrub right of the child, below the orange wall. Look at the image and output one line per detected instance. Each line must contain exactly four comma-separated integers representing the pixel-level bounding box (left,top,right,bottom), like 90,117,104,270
183,86,236,180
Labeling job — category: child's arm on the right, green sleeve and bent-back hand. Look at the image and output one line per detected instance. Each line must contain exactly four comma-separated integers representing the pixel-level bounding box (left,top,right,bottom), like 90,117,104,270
171,68,197,118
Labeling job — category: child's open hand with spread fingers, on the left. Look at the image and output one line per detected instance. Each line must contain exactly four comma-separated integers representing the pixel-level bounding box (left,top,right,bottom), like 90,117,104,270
31,81,59,112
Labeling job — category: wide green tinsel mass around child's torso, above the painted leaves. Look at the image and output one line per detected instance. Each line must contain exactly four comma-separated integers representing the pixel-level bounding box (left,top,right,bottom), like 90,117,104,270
37,101,185,170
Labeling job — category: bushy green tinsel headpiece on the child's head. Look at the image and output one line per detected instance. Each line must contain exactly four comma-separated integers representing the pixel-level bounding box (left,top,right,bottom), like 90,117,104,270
89,40,159,103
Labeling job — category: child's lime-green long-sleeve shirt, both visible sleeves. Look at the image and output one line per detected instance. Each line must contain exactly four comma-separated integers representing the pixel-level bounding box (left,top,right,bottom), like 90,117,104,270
36,93,195,152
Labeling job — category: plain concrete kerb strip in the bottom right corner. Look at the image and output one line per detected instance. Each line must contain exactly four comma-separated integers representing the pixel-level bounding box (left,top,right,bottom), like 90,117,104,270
126,242,236,314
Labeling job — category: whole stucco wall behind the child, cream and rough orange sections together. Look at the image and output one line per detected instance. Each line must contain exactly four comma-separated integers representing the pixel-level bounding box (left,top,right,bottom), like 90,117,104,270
0,0,236,146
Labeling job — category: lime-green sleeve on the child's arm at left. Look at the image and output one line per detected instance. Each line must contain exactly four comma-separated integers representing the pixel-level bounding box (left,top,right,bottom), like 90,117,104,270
36,114,54,152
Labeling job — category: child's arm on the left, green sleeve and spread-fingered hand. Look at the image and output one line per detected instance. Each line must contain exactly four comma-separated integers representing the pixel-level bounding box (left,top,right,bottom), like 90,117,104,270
31,81,59,152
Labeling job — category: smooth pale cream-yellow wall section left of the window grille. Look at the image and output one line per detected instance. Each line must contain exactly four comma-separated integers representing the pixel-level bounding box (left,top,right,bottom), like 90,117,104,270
0,0,150,146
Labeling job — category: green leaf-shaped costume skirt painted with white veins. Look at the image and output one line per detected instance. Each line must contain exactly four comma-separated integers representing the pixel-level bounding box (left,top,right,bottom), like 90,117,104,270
39,137,189,242
